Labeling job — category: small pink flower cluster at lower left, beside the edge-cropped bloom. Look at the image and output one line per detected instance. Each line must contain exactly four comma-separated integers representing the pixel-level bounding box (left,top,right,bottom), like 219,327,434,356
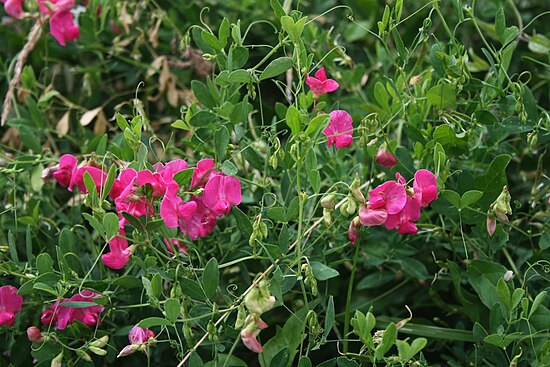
40,289,104,330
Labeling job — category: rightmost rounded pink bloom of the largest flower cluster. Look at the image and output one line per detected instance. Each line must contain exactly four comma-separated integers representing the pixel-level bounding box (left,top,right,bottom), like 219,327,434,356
202,174,242,217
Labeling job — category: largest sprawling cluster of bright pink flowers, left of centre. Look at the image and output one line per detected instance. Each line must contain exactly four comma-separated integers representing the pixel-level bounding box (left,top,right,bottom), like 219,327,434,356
47,154,242,269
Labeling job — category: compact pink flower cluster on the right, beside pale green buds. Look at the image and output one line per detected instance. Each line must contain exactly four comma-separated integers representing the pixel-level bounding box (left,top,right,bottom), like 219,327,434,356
359,169,438,234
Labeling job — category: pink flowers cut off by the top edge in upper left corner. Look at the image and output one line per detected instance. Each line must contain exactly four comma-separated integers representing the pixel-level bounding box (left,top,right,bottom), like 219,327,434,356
0,0,80,46
